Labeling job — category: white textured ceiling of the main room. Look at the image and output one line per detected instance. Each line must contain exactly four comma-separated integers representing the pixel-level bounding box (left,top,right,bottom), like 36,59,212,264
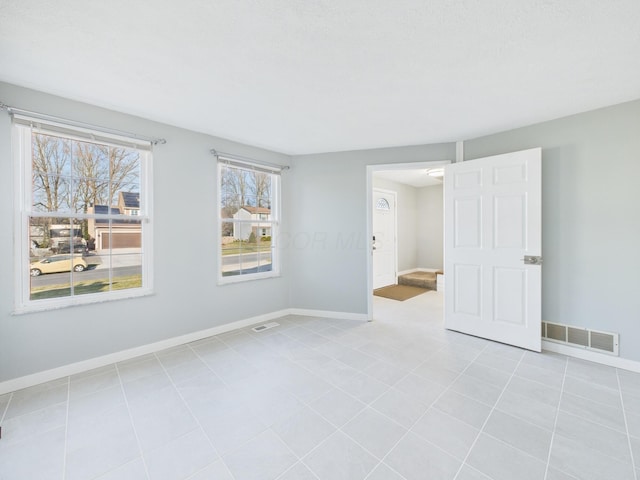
0,0,640,154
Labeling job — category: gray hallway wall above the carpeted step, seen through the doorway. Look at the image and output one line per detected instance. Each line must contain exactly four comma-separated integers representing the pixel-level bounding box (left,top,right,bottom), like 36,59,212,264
417,185,444,269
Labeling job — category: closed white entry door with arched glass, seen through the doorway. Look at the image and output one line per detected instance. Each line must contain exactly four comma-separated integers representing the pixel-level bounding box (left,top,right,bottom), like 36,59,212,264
372,188,397,289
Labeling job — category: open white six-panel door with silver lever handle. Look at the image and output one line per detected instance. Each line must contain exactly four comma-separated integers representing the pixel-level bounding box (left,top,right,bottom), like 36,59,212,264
444,148,542,352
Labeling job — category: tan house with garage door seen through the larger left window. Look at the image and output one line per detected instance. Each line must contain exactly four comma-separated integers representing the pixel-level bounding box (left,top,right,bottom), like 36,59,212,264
87,192,142,253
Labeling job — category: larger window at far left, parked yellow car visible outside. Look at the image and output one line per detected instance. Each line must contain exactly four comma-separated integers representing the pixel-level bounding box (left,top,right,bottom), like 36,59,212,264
14,115,151,312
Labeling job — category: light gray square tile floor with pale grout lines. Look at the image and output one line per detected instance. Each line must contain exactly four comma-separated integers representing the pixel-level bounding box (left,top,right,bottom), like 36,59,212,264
0,292,640,480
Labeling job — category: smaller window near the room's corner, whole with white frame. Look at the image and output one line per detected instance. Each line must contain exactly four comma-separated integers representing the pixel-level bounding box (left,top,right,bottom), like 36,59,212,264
218,157,280,283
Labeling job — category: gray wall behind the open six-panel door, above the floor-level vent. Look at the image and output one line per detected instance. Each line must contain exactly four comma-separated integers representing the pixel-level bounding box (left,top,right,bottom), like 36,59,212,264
464,101,640,361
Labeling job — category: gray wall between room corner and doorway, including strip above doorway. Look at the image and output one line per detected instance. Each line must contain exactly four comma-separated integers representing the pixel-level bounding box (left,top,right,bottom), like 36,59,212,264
289,143,455,313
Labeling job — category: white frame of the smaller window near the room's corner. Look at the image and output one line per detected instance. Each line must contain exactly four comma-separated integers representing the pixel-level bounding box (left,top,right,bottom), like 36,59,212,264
216,156,282,285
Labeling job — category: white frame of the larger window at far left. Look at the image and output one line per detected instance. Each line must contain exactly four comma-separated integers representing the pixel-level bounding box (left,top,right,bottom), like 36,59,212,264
12,121,153,314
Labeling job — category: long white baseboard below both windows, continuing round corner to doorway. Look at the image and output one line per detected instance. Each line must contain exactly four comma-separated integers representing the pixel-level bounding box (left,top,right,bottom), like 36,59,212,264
0,308,367,395
